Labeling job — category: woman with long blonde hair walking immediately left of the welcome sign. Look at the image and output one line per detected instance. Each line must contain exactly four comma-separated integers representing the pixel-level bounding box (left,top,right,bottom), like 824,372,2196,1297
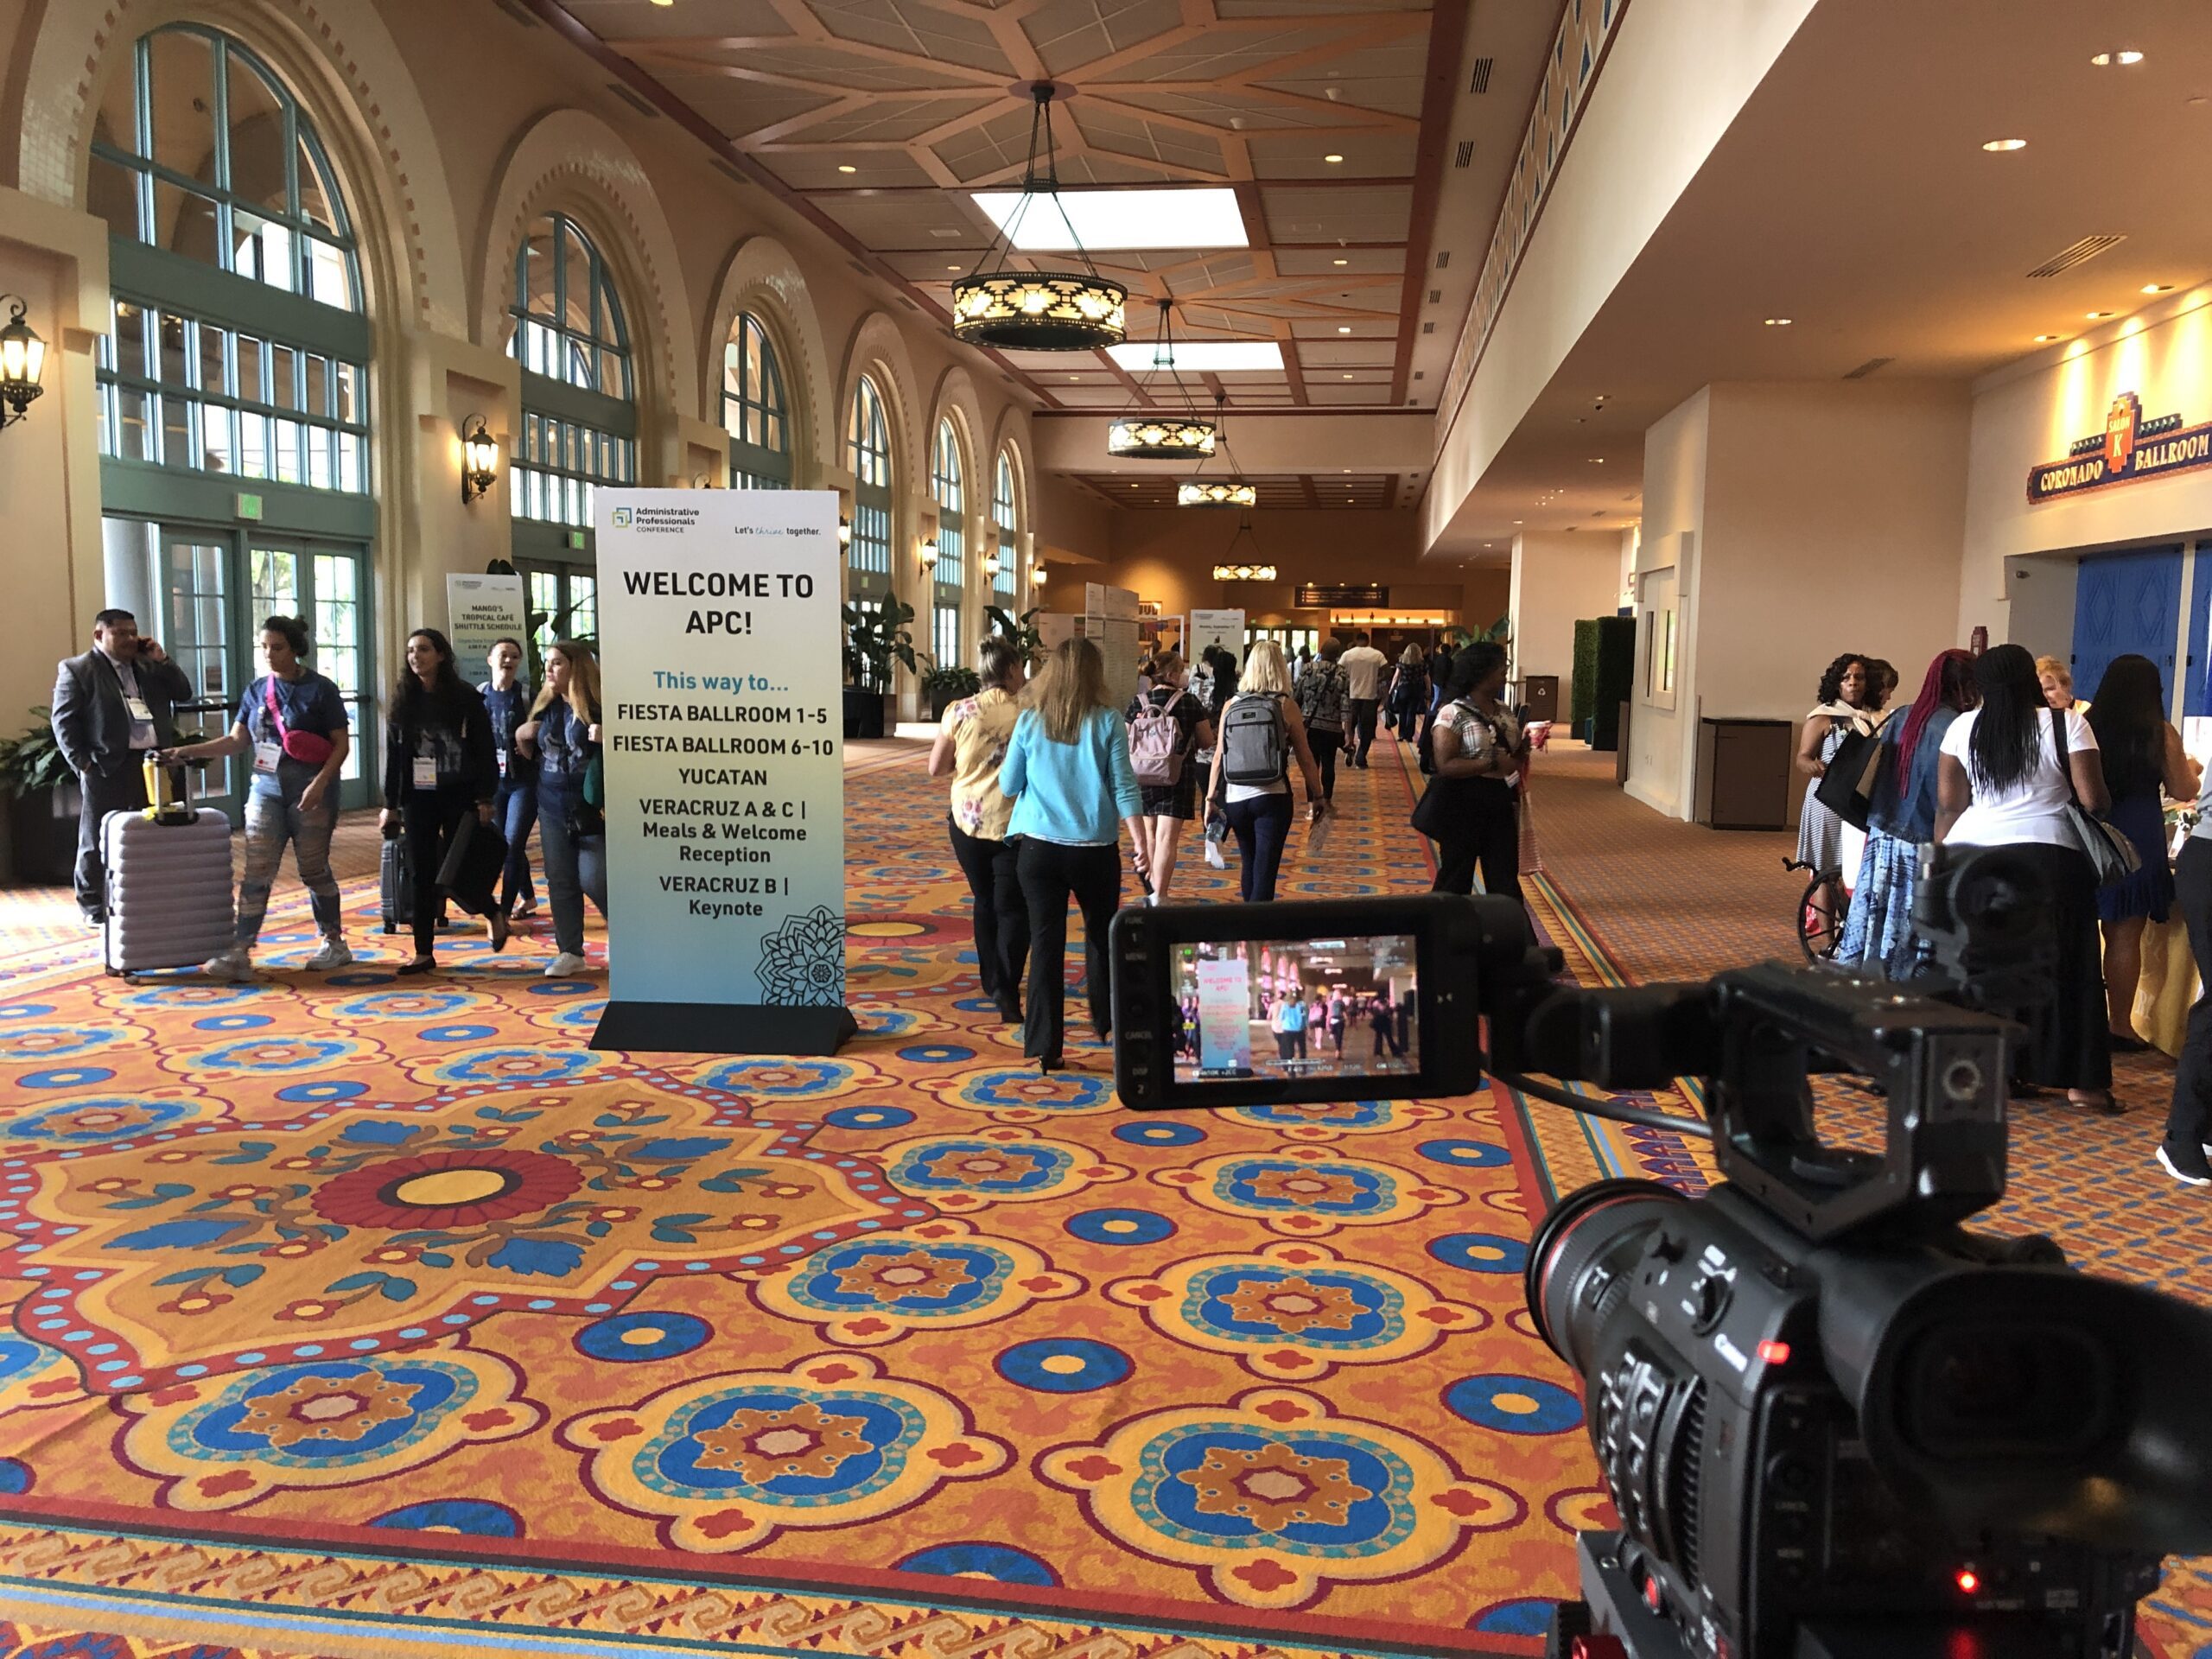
515,639,606,980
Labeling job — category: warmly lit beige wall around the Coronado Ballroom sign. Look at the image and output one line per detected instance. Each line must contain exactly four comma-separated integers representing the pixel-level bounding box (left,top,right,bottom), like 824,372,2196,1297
1958,288,2212,652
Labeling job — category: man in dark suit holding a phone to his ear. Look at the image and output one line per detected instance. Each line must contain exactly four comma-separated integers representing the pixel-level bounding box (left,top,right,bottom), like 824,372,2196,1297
53,611,193,927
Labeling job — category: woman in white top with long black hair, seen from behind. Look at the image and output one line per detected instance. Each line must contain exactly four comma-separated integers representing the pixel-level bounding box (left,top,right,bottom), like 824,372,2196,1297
1936,646,2121,1115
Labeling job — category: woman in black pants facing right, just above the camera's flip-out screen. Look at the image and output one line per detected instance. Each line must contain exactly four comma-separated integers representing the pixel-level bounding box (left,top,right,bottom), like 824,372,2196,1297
1429,639,1529,898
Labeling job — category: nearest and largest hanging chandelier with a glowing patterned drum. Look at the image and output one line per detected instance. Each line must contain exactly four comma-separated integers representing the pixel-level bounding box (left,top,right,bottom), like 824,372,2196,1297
953,79,1128,352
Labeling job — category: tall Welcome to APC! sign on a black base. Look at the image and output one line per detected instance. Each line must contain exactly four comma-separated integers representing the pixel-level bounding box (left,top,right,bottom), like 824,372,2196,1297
593,489,854,1055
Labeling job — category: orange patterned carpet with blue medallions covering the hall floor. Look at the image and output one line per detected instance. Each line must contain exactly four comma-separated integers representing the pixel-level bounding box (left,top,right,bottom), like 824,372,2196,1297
0,746,2212,1659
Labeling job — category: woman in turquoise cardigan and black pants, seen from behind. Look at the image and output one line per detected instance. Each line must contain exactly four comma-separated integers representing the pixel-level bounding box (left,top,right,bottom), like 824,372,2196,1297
998,639,1146,1073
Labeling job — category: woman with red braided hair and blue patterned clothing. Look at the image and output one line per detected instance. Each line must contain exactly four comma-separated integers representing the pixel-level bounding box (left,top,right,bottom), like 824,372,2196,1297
1836,651,1980,980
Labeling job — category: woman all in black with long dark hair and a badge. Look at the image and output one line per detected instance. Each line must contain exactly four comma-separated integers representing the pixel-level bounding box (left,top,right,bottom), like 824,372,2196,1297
376,628,506,973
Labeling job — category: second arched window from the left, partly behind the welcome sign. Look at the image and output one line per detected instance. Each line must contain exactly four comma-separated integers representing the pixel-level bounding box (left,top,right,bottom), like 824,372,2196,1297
506,213,637,646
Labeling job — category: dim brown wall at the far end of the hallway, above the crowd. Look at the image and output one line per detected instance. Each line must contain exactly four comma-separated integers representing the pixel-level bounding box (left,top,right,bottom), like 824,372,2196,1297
1030,505,1506,650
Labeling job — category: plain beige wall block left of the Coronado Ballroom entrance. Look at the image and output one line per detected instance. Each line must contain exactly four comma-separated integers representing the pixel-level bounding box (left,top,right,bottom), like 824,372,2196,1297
1630,383,1968,817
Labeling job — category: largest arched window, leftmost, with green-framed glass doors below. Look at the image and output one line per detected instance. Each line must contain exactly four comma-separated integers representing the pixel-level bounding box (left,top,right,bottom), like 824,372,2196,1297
86,24,376,827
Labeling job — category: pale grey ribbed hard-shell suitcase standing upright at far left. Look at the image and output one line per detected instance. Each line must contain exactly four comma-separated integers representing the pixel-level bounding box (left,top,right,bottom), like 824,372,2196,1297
99,761,237,973
